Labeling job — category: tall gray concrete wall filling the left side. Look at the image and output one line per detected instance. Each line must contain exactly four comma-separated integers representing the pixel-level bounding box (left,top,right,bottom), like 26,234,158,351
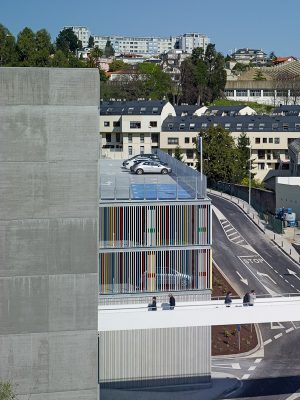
0,68,99,400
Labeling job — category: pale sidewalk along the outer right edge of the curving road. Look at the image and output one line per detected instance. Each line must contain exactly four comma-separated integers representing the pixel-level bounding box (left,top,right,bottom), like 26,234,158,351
207,189,300,264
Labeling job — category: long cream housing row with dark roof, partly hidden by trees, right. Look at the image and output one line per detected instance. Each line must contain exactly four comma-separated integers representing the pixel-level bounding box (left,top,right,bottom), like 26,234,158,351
160,115,300,180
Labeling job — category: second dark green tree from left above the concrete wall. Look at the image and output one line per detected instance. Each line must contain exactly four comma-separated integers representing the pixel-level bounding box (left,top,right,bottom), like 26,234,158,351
17,27,36,67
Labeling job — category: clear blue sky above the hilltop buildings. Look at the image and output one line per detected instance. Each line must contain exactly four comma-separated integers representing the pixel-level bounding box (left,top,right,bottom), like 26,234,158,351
0,0,300,57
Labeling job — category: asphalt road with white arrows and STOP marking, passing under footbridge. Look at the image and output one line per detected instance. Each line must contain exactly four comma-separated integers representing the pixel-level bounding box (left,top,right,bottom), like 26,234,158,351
211,195,300,400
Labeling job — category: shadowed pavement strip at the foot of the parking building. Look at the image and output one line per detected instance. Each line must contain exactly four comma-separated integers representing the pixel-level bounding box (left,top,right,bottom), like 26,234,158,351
100,372,241,400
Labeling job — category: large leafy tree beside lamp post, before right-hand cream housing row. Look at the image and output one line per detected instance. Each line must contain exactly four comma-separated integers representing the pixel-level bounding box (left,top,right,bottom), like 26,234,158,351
197,125,239,183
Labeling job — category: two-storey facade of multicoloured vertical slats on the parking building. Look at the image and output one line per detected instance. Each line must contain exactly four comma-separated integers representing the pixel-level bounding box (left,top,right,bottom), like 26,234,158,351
99,201,211,294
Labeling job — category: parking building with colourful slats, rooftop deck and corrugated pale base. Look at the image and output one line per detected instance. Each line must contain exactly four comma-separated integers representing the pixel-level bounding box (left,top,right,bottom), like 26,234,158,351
99,155,212,392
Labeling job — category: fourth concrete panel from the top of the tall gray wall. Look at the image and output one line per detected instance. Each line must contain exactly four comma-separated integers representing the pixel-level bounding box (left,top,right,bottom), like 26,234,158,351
0,218,97,277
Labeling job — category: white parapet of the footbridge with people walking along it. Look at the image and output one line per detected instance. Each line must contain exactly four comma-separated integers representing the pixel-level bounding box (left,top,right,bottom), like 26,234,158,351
98,296,300,332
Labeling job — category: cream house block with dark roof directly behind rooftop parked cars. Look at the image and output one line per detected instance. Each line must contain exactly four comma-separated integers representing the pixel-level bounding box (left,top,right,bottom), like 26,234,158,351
100,100,176,159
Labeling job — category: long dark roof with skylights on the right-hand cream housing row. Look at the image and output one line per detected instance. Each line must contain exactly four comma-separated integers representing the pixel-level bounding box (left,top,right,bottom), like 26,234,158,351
162,115,300,137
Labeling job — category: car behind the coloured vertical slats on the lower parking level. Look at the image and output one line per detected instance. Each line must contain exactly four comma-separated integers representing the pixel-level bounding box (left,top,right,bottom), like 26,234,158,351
144,267,192,290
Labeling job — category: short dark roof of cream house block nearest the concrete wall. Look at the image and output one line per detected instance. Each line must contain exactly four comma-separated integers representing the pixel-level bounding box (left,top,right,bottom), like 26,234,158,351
100,100,168,115
